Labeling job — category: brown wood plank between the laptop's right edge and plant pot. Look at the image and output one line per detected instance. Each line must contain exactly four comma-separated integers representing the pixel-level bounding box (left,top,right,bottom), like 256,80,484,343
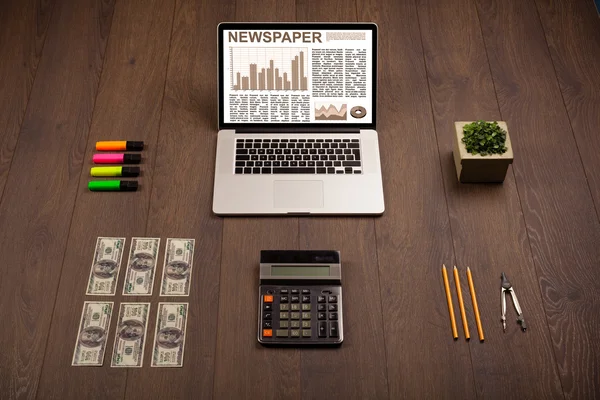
358,1,475,398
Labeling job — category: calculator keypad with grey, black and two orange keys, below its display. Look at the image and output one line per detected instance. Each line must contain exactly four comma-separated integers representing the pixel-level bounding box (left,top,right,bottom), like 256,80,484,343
259,286,343,345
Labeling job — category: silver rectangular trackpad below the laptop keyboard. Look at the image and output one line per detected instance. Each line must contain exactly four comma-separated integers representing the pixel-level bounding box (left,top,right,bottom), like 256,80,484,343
273,181,323,209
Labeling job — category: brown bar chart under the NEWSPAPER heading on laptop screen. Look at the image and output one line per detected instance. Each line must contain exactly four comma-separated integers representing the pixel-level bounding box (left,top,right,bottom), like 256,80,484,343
229,47,308,90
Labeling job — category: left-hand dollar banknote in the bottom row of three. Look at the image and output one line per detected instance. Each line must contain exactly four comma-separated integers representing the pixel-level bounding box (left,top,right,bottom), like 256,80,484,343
71,301,114,366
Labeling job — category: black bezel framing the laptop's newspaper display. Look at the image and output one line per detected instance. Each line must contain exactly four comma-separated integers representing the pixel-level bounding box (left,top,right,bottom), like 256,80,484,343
217,22,377,132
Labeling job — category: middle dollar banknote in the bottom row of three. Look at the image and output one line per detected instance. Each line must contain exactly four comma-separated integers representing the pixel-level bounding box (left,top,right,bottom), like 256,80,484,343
110,303,150,367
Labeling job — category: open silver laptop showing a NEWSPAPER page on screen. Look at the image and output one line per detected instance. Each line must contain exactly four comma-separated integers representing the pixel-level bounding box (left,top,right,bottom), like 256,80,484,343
213,23,384,215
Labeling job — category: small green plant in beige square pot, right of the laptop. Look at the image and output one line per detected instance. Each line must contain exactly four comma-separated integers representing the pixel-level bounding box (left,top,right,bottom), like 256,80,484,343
453,121,513,183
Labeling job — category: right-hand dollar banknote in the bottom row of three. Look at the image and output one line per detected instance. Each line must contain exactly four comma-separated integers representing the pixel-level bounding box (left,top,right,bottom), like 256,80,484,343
152,303,188,367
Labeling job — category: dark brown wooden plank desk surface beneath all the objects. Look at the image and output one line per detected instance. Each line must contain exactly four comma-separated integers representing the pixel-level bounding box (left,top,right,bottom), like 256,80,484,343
0,0,600,399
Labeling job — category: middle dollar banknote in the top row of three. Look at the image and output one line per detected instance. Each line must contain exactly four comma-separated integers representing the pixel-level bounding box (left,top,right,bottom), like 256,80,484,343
123,238,160,296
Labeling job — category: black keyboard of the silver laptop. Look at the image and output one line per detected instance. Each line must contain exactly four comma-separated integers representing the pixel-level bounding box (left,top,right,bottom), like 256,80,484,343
234,138,362,174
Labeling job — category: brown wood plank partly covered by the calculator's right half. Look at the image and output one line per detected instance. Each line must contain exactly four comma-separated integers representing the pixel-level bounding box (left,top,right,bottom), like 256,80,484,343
297,0,388,399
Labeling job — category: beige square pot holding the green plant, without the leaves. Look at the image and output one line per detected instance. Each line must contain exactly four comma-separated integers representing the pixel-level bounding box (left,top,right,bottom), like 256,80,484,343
453,121,513,183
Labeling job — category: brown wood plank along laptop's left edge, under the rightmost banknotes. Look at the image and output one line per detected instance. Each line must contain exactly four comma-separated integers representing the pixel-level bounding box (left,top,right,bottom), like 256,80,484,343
125,1,230,399
